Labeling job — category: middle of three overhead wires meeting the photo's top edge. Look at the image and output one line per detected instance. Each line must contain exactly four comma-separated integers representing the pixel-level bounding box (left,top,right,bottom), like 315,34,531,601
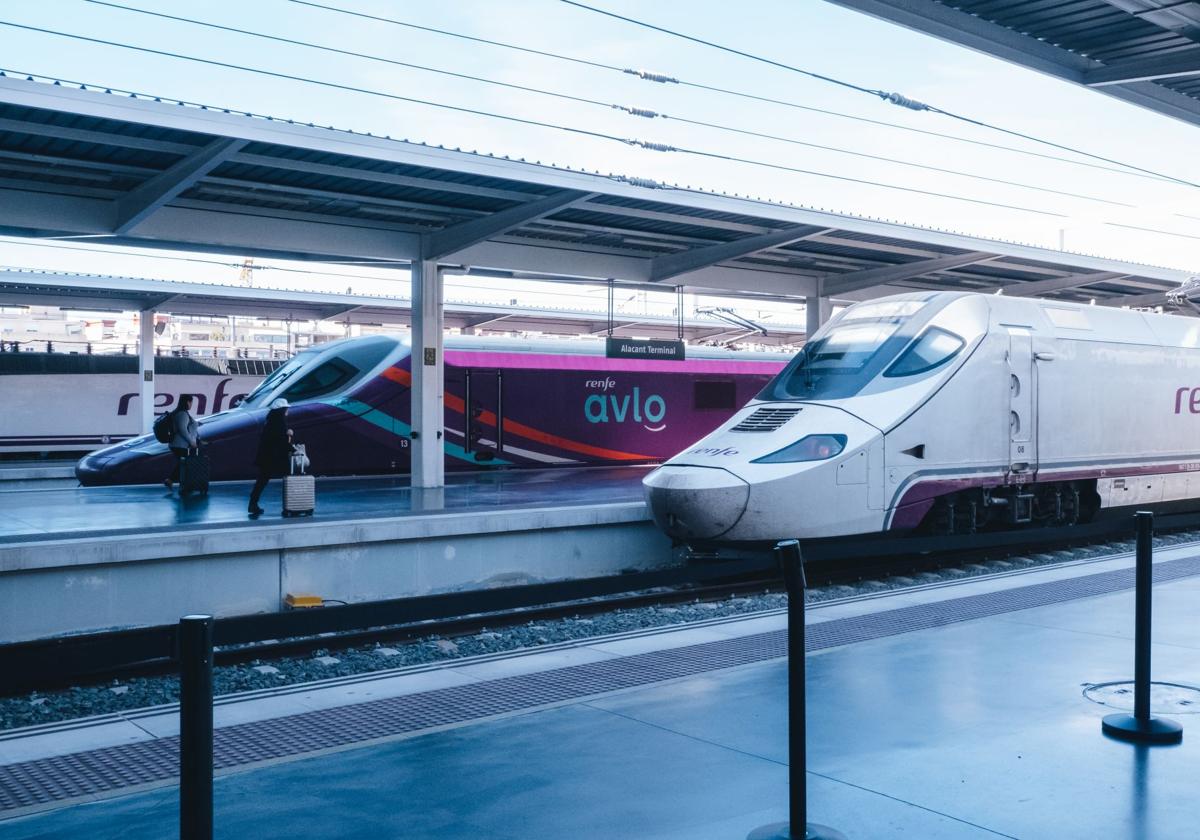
288,0,1174,181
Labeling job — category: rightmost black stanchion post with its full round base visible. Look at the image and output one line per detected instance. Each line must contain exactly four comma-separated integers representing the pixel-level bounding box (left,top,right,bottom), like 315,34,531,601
1102,510,1183,744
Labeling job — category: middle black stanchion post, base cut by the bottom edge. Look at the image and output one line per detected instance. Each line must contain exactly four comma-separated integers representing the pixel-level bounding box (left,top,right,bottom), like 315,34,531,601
748,540,845,840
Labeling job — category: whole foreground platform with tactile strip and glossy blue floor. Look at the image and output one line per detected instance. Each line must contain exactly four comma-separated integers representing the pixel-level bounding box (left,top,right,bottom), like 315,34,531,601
0,546,1200,840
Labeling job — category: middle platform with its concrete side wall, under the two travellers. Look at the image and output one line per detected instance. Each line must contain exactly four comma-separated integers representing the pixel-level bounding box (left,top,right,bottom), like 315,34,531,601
0,467,673,643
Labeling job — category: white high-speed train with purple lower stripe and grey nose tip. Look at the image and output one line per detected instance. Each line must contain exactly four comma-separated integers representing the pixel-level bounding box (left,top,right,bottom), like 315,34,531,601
644,292,1200,546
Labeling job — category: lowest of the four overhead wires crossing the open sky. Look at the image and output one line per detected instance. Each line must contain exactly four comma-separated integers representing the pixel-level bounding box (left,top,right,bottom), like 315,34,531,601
0,20,1089,218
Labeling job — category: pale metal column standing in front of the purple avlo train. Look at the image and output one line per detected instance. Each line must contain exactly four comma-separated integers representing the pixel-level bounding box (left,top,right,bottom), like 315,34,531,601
412,259,445,487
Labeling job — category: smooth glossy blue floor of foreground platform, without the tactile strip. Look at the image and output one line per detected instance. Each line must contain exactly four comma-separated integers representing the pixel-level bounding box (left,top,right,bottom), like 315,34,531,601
0,552,1200,840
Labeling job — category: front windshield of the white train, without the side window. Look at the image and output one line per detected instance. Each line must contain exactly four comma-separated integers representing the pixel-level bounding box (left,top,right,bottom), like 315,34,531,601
758,300,925,400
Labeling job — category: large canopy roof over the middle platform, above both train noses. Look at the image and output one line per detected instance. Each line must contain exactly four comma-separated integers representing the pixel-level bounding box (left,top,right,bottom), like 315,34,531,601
0,72,1186,305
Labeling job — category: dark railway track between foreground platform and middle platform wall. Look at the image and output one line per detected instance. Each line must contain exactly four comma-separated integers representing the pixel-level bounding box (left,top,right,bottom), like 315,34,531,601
9,514,1200,696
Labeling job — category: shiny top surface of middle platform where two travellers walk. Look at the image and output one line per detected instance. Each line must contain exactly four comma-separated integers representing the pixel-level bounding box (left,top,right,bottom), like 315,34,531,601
0,467,650,542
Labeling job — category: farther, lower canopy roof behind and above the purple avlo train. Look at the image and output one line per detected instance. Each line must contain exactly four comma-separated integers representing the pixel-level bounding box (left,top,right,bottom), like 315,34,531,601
0,270,804,344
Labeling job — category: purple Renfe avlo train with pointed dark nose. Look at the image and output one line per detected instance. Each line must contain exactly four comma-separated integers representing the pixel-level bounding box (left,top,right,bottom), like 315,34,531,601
76,336,787,485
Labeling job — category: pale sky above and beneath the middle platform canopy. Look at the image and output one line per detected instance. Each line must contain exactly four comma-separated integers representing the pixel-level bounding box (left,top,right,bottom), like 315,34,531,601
0,0,1200,321
